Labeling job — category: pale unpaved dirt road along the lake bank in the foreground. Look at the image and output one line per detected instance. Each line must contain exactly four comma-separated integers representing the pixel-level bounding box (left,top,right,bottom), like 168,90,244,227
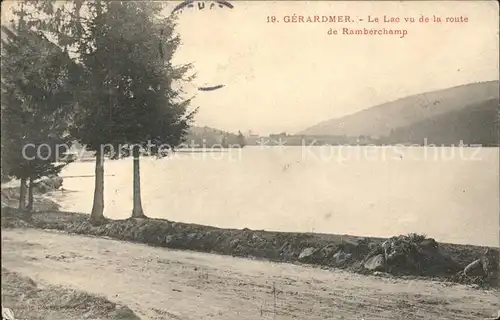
2,230,500,320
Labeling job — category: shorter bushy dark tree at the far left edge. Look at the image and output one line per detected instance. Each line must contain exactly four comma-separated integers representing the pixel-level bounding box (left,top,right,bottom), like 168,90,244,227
2,20,75,210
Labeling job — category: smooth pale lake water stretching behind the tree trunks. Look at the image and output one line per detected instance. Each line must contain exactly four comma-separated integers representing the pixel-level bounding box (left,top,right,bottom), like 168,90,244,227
54,147,500,245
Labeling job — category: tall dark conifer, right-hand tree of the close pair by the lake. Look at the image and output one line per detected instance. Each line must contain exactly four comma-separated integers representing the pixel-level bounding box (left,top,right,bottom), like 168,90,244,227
71,2,194,218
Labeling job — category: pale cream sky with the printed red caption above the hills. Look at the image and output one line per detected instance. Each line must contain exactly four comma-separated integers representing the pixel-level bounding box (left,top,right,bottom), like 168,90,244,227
2,1,499,134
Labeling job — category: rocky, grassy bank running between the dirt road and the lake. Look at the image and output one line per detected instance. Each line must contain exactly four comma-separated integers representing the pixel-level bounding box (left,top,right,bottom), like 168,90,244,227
2,207,499,288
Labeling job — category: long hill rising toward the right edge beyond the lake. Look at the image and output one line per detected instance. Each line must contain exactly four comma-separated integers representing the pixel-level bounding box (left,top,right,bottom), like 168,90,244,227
300,81,499,142
